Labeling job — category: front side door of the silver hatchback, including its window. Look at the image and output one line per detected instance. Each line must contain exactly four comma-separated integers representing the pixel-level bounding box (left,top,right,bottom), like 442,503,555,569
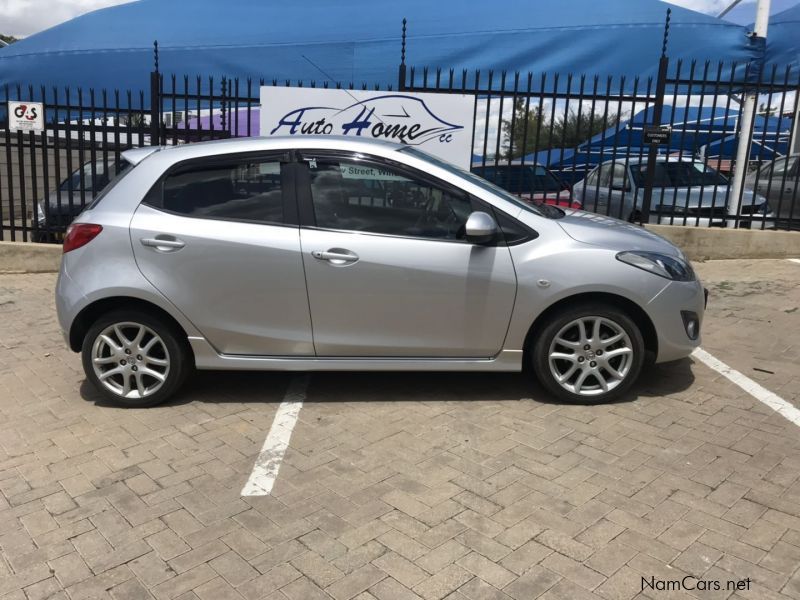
298,153,516,357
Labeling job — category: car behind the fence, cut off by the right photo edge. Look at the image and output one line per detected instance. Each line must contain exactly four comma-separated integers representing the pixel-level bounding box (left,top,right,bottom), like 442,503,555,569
745,154,800,227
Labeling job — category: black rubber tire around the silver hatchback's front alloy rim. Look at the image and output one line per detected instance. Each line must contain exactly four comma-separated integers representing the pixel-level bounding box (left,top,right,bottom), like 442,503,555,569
531,302,645,404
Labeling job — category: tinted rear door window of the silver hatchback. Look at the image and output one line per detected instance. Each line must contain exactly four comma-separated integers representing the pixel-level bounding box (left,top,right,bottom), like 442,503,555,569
161,161,284,223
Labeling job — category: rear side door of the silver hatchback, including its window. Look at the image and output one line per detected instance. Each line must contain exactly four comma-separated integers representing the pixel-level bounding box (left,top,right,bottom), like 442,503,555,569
130,155,314,356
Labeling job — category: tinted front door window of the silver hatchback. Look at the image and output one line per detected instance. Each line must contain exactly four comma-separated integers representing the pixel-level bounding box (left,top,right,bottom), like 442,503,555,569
309,158,472,240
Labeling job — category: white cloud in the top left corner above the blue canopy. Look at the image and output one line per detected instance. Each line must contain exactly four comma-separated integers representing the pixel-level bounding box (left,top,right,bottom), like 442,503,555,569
0,0,136,37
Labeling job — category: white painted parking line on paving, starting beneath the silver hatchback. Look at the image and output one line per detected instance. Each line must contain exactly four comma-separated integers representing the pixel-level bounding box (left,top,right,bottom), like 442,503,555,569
241,375,308,496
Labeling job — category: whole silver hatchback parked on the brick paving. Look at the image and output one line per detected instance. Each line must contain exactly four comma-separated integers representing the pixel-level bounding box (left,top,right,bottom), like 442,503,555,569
56,137,705,406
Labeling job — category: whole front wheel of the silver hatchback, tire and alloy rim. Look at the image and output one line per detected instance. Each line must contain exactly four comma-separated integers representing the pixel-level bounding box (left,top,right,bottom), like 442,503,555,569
532,303,645,403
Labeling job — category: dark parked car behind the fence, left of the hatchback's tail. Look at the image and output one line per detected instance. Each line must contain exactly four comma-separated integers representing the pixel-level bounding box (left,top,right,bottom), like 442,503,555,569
33,161,128,242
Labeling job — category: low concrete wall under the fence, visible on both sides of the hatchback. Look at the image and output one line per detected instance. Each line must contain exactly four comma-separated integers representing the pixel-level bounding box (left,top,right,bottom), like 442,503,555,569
0,225,800,273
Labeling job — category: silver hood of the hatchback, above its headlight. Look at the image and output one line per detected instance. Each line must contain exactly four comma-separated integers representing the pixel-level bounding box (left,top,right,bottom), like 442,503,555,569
556,210,683,258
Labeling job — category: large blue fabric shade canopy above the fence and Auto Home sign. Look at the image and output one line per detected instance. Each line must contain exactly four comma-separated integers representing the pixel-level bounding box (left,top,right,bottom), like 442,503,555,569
0,0,757,96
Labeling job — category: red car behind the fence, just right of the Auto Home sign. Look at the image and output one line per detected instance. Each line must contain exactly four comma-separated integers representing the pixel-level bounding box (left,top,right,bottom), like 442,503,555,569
472,160,581,208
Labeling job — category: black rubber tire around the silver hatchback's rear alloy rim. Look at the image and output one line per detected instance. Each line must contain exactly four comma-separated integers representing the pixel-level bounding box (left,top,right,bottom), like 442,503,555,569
81,309,193,408
